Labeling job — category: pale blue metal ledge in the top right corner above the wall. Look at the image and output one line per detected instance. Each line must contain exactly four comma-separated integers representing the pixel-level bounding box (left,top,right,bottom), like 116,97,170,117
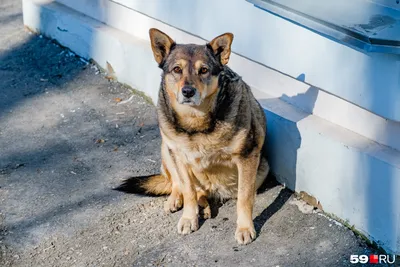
247,0,400,54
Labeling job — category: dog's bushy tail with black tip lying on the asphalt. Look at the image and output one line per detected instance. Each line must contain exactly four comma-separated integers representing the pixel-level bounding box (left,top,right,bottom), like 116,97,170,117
114,174,172,196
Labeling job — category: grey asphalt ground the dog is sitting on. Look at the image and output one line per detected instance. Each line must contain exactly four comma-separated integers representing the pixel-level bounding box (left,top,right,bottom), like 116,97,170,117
0,0,386,266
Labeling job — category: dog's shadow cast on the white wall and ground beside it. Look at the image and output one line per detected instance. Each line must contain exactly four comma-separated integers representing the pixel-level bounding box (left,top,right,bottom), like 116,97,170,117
254,74,318,234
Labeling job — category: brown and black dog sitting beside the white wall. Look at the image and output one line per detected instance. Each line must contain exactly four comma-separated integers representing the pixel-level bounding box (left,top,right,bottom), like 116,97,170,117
118,28,269,244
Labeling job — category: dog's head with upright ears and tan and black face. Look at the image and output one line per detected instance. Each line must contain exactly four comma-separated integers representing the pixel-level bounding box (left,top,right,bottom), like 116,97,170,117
149,29,233,106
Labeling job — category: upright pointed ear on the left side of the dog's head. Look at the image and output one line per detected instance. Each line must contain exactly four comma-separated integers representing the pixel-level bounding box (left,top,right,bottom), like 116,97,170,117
149,28,175,67
